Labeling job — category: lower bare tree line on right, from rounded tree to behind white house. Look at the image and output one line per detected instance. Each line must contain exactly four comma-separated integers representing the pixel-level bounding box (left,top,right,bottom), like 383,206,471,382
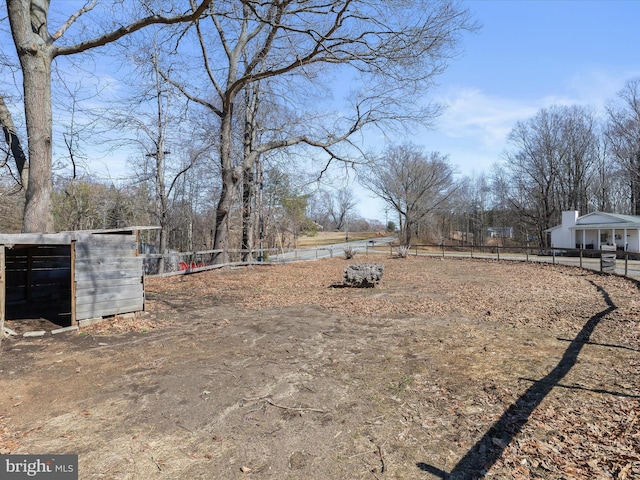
363,78,640,247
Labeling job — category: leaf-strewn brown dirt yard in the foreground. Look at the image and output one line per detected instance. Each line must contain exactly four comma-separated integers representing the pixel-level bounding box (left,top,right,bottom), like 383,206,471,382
0,256,640,480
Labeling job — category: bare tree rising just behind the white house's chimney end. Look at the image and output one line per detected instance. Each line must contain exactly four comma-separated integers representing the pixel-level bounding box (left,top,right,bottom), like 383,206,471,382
502,106,600,246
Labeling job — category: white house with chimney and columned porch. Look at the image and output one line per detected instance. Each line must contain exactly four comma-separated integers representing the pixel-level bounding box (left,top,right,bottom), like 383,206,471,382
547,211,640,252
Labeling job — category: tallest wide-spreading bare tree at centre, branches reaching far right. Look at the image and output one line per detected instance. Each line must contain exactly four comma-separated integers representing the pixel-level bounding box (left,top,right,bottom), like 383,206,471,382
161,0,475,262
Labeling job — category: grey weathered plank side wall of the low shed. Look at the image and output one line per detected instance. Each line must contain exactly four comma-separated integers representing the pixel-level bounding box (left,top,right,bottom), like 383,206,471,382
73,235,144,320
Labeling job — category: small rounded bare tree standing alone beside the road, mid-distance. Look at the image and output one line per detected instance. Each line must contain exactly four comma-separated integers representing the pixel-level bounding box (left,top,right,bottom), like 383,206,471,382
362,144,456,245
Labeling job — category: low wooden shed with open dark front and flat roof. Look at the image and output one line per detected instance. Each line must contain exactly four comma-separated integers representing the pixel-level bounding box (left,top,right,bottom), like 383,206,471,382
0,227,157,326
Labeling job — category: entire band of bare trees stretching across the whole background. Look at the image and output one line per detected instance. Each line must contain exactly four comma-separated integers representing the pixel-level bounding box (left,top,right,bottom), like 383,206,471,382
0,0,640,255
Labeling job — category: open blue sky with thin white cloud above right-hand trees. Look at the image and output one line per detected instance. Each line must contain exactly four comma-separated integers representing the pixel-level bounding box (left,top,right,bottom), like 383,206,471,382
360,0,640,219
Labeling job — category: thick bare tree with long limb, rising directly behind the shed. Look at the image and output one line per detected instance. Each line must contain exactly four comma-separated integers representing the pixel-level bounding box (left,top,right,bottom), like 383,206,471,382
0,0,211,232
